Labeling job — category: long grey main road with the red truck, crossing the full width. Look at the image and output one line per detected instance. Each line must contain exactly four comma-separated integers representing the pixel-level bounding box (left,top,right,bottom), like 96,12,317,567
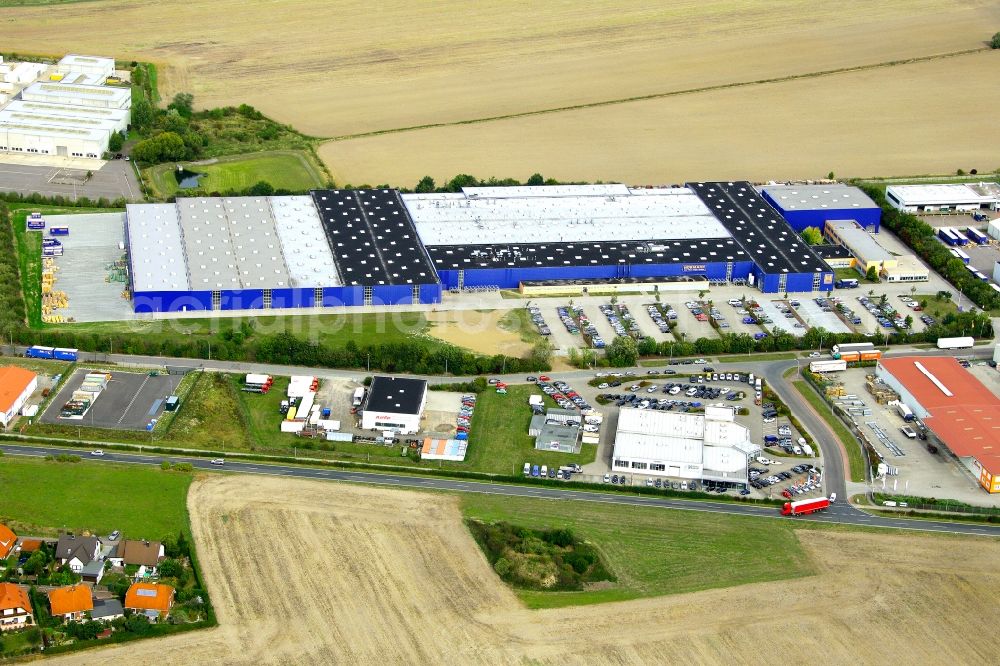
0,444,1000,537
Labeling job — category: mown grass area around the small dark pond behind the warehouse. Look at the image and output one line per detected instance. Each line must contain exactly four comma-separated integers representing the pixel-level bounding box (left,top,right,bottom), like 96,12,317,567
146,150,325,198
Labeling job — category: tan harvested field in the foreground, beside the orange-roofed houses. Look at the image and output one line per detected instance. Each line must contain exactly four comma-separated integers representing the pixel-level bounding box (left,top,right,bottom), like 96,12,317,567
51,475,1000,666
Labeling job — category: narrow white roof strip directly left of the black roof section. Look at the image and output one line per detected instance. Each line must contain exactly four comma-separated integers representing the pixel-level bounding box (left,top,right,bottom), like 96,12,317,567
268,195,342,287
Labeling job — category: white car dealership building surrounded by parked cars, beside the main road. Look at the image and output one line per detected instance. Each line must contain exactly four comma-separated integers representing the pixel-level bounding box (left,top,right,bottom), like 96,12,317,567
611,407,761,484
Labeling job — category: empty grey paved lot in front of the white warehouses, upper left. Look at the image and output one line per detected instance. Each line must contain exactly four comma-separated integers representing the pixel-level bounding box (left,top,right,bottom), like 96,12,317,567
0,158,142,201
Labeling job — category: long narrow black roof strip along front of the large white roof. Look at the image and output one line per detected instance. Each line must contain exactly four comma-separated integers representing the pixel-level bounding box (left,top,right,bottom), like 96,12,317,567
427,238,750,270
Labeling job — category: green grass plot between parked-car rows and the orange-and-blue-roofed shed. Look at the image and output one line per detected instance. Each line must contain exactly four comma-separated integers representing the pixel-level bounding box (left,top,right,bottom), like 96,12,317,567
458,384,597,475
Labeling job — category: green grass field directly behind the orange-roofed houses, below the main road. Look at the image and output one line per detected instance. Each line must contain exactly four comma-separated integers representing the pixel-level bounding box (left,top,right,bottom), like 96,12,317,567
0,455,191,539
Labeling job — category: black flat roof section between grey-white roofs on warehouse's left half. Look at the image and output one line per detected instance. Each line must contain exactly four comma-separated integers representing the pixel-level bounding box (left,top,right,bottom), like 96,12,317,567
312,190,437,286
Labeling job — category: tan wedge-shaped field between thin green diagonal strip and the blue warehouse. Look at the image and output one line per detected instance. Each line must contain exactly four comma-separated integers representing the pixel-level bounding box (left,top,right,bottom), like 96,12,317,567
319,49,1000,187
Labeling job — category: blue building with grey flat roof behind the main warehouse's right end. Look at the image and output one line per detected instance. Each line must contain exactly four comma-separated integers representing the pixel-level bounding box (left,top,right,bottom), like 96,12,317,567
760,183,882,233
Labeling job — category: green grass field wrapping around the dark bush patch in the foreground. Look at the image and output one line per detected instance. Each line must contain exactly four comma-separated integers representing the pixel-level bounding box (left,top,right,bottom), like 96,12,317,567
461,494,814,608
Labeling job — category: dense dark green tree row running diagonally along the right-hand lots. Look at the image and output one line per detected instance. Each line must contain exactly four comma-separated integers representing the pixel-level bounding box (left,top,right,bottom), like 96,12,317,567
861,185,1000,310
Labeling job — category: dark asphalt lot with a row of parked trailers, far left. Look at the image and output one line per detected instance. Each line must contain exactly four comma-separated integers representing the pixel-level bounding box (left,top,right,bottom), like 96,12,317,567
41,368,183,430
